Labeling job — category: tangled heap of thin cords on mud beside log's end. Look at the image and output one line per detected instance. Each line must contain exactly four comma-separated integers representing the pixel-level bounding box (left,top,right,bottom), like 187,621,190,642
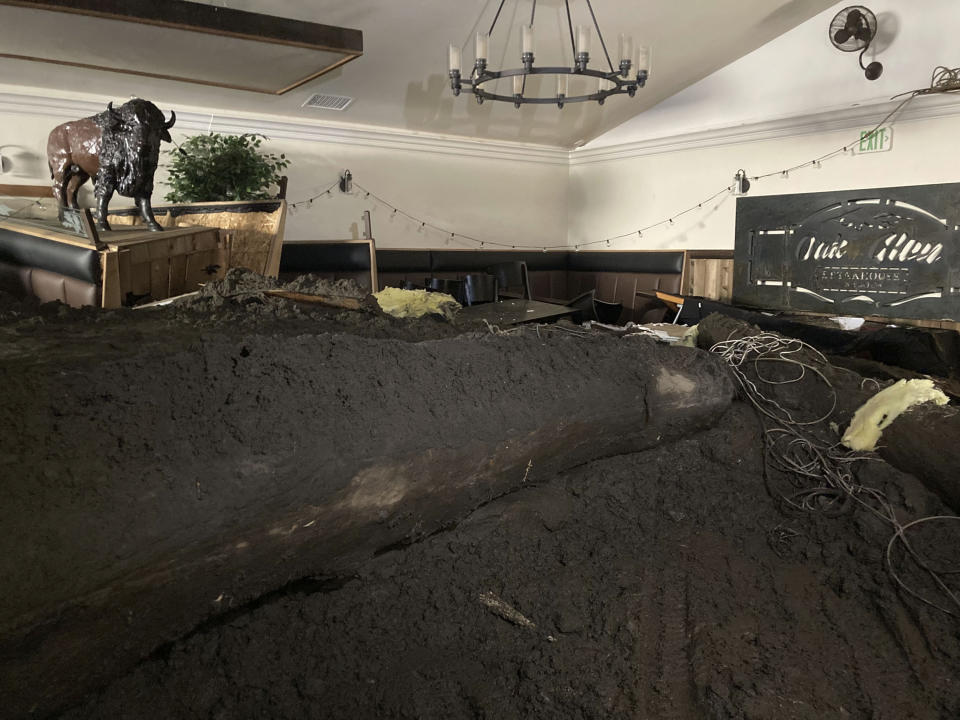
710,333,960,617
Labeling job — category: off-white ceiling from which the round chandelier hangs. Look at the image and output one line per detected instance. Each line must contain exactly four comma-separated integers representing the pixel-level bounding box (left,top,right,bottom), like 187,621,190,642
0,0,834,148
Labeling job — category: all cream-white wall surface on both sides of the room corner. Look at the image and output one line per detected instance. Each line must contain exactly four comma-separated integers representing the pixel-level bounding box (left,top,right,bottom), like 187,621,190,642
0,0,960,258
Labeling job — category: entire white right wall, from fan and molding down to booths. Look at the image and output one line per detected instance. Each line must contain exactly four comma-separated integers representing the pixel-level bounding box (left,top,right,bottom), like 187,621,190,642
568,0,960,249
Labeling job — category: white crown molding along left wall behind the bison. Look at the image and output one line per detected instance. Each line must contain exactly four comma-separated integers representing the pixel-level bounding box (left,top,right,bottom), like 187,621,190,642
0,92,570,166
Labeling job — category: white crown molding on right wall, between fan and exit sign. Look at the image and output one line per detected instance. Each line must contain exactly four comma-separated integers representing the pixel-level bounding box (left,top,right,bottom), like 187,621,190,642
570,95,960,166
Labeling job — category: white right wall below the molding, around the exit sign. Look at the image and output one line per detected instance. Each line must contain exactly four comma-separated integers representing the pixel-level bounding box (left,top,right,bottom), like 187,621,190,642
569,109,960,249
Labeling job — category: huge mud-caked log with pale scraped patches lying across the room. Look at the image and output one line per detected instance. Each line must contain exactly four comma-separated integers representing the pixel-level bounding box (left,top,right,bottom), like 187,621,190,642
0,282,733,717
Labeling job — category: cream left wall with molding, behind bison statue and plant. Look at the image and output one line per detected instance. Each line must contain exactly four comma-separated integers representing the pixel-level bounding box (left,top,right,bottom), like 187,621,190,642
0,86,568,248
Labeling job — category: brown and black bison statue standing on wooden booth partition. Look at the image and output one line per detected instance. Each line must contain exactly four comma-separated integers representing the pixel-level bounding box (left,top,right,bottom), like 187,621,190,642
47,98,177,230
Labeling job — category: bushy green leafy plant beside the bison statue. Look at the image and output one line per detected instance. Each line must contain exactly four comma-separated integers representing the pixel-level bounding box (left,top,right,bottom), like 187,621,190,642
166,133,290,203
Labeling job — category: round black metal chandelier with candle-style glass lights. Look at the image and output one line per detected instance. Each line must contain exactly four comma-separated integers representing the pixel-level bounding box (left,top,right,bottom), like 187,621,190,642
450,0,650,108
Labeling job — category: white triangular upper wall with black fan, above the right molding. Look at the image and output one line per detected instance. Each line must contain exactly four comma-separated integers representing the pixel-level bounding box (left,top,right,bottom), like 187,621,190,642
588,0,960,148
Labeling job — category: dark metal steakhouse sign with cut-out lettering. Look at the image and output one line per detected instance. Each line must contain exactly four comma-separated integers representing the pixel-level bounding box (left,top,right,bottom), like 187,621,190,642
734,183,960,320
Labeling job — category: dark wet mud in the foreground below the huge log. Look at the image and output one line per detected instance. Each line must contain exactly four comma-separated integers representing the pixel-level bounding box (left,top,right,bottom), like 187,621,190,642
63,404,960,720
